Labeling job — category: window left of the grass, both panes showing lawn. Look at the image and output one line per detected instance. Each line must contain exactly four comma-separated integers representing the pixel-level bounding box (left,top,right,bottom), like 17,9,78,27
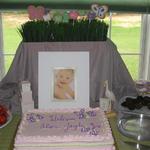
2,11,28,73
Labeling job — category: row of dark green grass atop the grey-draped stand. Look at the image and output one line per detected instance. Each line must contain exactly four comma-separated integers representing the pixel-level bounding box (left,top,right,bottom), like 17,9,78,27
18,20,108,42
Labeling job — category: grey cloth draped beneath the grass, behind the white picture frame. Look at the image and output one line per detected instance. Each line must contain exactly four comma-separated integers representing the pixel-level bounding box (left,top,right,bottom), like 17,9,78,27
0,39,137,108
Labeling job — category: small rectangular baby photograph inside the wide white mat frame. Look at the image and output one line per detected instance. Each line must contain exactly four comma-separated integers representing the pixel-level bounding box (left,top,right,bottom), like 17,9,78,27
53,68,75,101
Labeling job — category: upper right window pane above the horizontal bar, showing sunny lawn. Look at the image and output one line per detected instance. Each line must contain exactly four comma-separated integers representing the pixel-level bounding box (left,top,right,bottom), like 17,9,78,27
111,13,141,53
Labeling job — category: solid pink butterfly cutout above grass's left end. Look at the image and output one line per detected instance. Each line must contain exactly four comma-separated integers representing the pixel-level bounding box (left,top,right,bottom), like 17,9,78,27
27,5,45,20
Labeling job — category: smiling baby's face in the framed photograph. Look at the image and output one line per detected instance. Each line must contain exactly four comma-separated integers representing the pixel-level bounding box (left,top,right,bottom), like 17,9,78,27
56,70,73,84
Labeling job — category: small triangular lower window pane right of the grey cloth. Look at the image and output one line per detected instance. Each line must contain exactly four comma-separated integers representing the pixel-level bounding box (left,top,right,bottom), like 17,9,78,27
121,55,140,80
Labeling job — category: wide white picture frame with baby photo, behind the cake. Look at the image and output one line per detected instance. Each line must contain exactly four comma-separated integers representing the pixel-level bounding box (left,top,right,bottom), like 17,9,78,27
38,51,89,109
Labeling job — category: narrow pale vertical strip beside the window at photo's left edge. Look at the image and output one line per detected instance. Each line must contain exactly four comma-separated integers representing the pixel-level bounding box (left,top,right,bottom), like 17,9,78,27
0,13,5,81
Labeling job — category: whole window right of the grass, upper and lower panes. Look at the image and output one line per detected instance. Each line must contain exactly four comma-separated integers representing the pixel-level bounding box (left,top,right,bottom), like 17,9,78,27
109,13,141,80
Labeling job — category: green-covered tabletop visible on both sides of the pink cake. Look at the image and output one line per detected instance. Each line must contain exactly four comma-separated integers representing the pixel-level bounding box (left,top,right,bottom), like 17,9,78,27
0,115,150,150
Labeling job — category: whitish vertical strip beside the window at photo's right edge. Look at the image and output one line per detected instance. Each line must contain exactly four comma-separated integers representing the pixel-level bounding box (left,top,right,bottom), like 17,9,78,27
139,14,150,80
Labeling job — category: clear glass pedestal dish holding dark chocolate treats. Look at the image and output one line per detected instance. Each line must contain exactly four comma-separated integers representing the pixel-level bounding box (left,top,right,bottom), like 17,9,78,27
118,97,150,141
